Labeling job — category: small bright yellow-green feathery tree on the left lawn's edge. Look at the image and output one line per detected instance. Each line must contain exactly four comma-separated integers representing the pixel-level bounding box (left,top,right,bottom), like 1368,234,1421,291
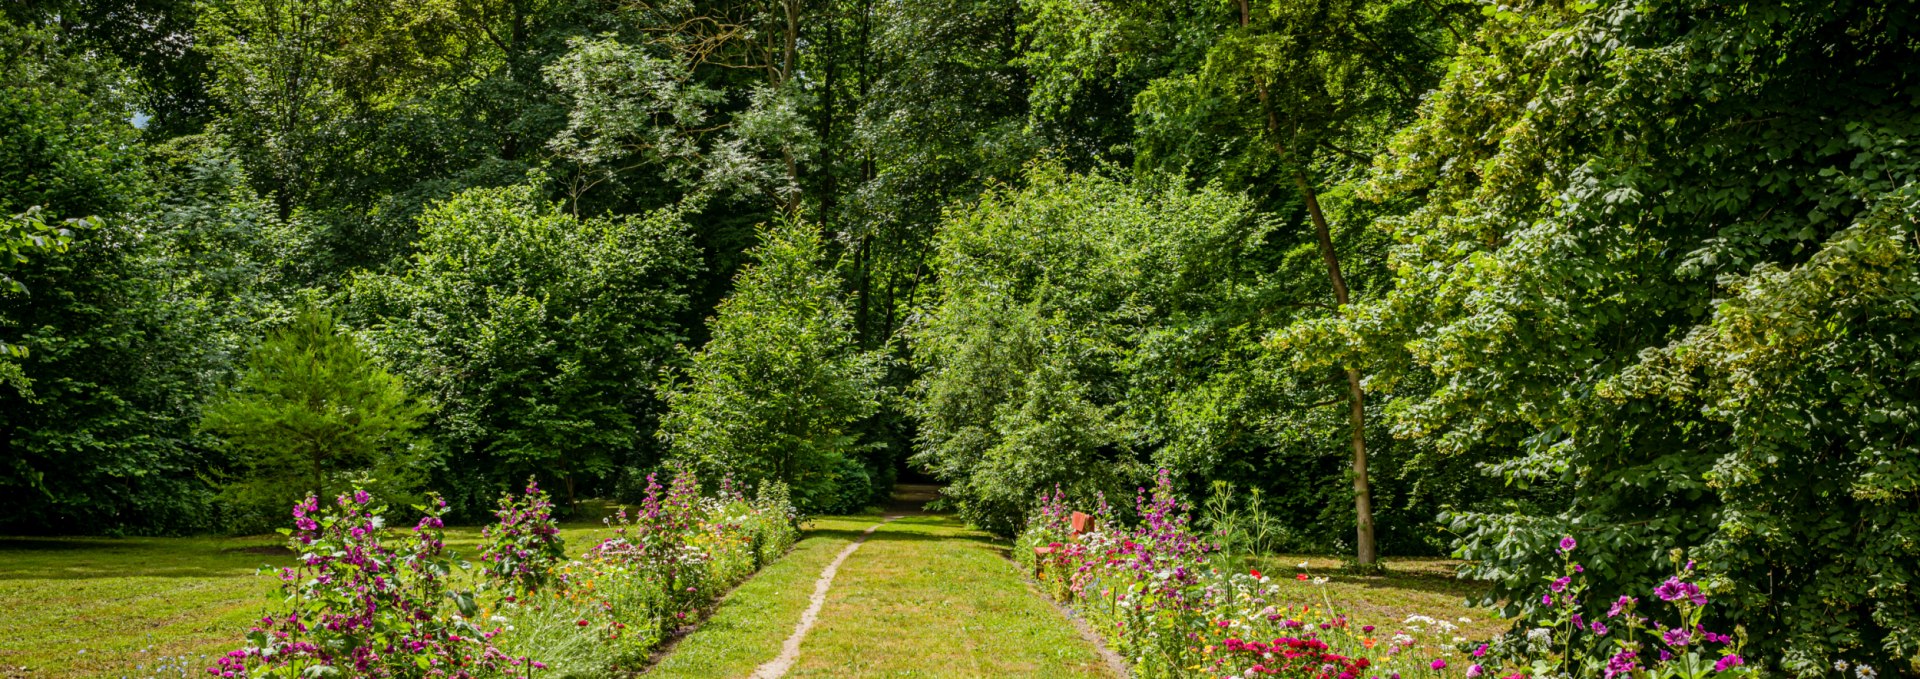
200,307,432,529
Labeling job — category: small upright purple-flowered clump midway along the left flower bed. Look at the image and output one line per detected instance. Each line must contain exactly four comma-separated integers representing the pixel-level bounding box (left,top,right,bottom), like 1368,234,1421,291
480,480,566,595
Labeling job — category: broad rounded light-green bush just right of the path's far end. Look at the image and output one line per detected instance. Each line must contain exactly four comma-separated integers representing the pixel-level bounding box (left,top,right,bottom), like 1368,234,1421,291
912,165,1271,533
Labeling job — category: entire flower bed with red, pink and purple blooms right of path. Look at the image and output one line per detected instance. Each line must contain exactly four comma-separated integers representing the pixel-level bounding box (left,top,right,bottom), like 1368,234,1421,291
1014,472,1751,679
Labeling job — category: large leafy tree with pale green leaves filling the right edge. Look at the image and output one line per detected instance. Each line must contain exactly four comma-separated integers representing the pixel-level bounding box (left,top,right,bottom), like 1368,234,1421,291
1298,2,1920,673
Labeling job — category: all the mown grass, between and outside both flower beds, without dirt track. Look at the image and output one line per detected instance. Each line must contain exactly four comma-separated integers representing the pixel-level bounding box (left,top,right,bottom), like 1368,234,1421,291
0,494,1505,679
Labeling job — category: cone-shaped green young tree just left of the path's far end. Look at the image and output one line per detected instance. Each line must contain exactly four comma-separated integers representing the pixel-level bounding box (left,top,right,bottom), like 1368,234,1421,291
660,219,891,514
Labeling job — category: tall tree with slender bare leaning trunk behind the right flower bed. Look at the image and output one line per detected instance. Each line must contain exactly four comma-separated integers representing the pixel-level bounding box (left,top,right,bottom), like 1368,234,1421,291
1027,0,1463,564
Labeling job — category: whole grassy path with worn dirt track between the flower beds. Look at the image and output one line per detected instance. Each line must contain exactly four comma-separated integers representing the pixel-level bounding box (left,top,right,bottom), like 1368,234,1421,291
647,485,1119,677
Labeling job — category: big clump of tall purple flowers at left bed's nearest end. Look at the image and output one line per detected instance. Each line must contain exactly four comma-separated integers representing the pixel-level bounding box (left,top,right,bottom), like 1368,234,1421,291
207,489,532,677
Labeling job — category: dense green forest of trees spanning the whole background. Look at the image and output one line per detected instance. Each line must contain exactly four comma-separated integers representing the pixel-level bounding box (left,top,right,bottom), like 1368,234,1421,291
0,0,1920,671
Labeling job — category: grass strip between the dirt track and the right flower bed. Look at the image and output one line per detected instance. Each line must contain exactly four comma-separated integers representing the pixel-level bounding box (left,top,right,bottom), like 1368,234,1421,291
789,516,1110,677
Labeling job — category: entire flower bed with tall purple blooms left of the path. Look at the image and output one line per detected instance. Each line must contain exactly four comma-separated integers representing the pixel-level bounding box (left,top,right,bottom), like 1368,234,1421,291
207,472,799,677
